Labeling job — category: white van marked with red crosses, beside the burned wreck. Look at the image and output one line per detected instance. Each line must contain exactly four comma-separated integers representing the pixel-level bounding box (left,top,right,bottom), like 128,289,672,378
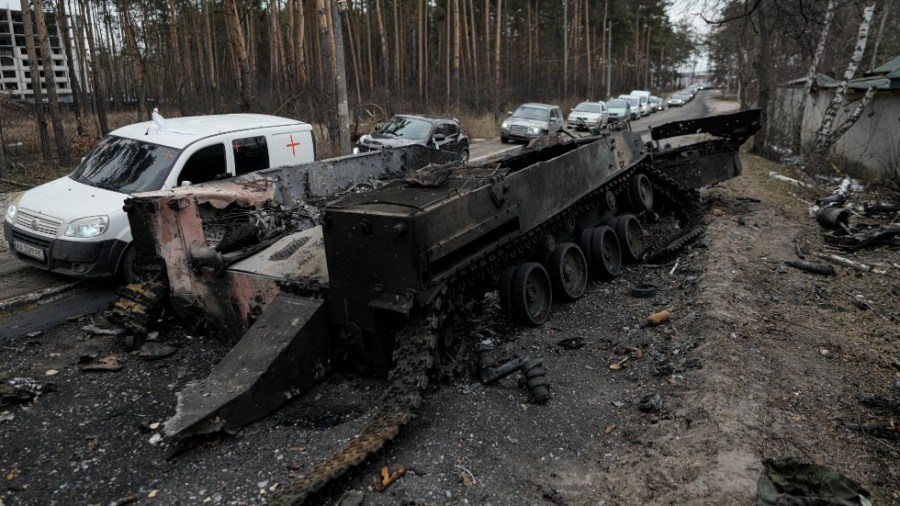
3,111,315,280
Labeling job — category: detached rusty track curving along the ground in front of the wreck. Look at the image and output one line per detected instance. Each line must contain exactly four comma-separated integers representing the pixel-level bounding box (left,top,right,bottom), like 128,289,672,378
269,315,437,506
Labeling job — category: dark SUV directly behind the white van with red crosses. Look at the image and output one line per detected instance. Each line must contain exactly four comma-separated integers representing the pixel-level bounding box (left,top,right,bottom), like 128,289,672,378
353,114,469,164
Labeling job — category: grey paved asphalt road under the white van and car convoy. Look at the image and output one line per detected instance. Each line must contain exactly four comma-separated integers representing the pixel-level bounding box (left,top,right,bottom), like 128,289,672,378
0,90,718,342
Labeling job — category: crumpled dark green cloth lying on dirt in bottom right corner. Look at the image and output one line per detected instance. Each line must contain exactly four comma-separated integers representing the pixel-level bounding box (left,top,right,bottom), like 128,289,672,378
756,458,872,506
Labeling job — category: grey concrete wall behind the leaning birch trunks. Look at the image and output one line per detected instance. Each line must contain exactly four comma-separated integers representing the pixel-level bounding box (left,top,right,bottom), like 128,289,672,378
772,88,900,180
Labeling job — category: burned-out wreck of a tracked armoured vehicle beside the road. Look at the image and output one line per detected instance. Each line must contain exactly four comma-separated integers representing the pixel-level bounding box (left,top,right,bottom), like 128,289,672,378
112,111,758,503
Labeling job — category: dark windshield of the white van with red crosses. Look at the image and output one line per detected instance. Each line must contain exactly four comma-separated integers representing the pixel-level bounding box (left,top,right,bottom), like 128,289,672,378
71,135,181,193
